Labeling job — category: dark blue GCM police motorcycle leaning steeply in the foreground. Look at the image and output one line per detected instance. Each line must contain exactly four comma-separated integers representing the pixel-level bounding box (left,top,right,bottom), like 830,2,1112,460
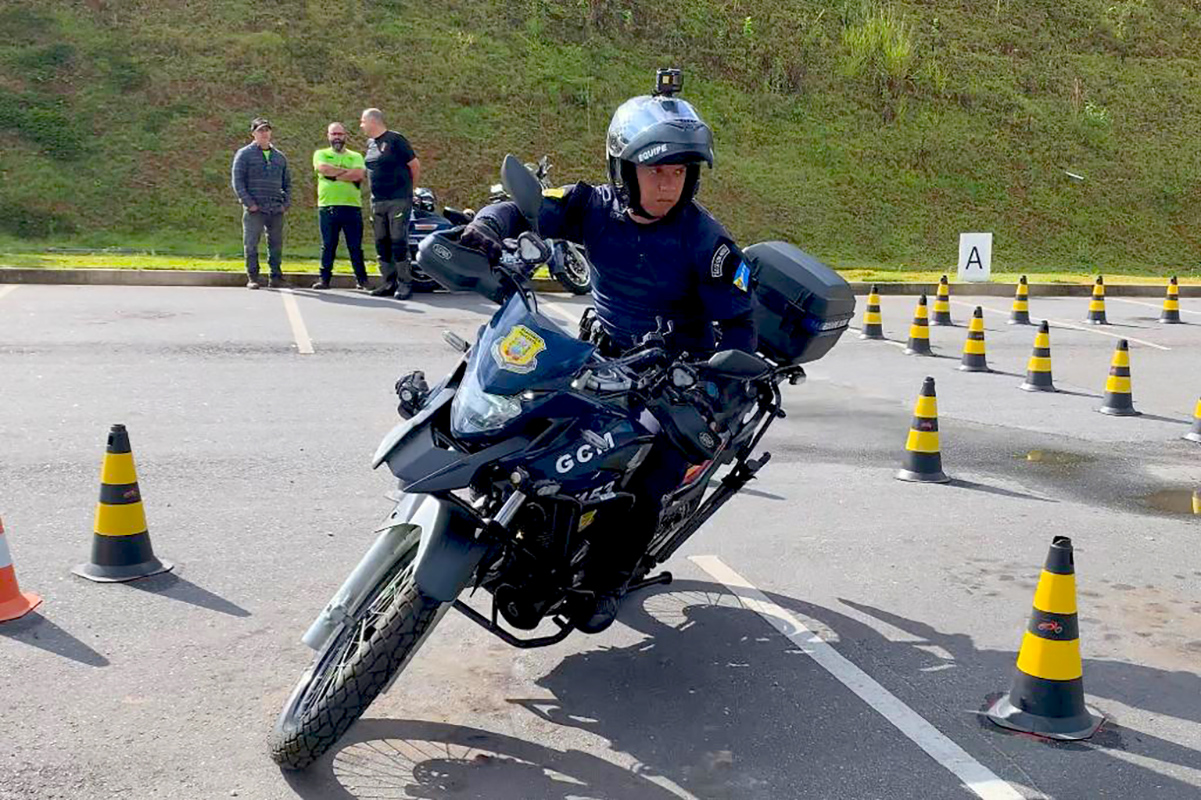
271,156,855,769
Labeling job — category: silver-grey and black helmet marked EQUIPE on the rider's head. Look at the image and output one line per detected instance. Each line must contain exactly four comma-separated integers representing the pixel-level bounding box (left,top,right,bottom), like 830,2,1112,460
607,75,713,211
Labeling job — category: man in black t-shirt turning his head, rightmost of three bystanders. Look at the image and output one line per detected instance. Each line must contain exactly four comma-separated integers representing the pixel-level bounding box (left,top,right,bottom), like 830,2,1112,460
359,102,422,295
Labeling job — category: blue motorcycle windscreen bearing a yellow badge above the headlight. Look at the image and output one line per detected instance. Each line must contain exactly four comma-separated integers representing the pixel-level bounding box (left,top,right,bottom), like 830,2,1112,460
472,295,596,395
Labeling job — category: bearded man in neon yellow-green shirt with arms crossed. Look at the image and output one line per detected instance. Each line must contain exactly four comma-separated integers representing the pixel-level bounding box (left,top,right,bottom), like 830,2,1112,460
312,123,371,292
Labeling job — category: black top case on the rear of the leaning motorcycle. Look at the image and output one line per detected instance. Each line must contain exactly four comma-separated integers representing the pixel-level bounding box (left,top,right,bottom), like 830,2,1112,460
743,241,855,364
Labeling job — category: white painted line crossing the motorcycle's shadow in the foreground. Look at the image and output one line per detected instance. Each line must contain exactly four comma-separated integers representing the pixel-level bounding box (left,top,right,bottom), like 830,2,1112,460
691,556,1022,800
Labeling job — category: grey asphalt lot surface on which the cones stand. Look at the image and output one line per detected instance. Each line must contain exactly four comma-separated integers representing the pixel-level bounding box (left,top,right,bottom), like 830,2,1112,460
0,286,1201,800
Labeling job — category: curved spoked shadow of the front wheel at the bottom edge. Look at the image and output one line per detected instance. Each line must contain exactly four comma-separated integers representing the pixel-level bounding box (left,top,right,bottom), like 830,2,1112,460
283,720,679,800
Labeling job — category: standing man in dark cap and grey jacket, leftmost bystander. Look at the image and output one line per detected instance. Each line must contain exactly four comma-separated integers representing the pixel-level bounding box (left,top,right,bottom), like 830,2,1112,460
231,117,292,288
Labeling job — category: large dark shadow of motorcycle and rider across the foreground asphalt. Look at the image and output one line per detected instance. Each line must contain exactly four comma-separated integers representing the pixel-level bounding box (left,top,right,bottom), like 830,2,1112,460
276,580,1201,800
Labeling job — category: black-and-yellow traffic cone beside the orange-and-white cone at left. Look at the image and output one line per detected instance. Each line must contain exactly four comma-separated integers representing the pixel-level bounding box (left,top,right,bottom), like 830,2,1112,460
71,425,173,584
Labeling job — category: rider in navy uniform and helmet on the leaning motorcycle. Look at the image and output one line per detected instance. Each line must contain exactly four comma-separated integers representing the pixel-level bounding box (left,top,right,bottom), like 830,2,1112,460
460,70,755,633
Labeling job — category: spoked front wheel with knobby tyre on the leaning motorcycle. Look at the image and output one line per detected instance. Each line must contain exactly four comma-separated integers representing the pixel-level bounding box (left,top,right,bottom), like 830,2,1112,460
270,533,449,770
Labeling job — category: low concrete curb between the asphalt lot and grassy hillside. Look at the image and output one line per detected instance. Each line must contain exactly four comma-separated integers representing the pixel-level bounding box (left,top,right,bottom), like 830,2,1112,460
0,267,1201,298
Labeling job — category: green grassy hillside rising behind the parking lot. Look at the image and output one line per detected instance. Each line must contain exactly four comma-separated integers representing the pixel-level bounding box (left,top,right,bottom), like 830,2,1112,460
0,0,1201,274
